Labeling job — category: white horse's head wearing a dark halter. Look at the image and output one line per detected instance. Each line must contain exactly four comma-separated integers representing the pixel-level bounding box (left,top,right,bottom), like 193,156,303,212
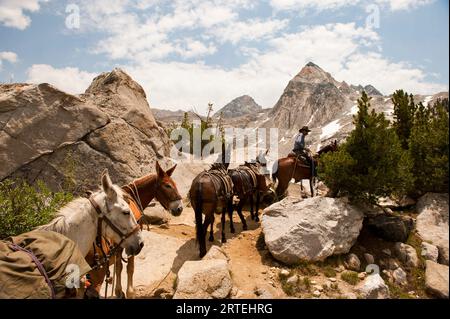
96,170,144,255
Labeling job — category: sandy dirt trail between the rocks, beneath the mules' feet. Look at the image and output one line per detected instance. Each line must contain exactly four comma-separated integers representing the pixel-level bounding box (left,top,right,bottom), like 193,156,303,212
147,207,287,298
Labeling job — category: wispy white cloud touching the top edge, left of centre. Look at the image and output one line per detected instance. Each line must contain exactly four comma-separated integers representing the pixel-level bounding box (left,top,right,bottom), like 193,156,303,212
74,0,287,62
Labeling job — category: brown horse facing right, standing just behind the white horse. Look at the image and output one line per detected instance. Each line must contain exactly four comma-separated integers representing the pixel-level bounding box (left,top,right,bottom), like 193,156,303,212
86,162,183,298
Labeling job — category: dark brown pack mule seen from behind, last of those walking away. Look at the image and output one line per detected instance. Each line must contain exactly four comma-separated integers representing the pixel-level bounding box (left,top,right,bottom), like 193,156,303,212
189,163,235,258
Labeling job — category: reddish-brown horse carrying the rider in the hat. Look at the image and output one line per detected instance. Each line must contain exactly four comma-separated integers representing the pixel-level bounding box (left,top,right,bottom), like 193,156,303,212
272,141,337,197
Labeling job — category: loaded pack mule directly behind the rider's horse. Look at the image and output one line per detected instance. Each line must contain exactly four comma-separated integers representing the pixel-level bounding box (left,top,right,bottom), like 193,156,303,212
228,150,269,230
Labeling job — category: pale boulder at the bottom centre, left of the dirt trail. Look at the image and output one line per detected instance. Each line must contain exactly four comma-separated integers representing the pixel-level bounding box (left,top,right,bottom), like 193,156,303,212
173,246,233,299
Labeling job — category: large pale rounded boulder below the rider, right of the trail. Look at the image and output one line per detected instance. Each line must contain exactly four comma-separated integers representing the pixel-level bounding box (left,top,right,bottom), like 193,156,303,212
262,197,363,264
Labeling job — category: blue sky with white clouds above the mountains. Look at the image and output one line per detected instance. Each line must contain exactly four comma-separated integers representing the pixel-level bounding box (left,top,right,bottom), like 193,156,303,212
0,0,449,113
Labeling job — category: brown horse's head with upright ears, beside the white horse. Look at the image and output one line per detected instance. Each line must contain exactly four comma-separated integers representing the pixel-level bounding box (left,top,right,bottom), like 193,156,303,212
156,162,183,216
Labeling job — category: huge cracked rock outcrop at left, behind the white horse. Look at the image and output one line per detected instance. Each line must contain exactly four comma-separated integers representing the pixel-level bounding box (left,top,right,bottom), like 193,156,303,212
0,69,171,193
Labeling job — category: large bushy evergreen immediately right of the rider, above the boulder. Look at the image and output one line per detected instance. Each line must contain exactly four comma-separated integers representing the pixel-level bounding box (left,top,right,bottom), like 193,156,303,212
319,92,413,202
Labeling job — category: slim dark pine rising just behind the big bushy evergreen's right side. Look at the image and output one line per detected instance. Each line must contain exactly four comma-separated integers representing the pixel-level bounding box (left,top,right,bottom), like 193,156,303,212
392,90,416,149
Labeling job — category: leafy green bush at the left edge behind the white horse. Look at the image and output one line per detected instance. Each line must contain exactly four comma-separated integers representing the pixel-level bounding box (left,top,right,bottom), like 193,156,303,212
0,179,73,239
